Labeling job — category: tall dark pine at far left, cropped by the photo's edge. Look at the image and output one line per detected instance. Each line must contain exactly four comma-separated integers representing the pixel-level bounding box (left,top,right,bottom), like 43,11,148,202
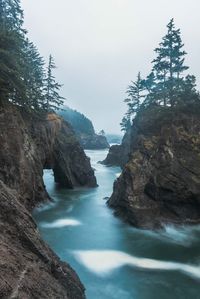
0,0,25,102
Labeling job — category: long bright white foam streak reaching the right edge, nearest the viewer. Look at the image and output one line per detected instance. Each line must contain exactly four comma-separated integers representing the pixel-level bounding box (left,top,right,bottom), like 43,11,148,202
74,250,200,279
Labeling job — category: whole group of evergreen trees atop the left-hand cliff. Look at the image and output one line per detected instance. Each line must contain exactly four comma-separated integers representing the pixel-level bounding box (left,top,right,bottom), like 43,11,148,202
0,0,63,112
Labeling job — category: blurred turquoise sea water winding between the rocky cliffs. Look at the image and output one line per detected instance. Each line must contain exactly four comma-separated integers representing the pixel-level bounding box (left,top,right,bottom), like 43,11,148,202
34,150,200,299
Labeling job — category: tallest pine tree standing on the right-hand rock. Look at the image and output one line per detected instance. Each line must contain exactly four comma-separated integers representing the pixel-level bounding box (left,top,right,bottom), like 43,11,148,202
152,19,188,106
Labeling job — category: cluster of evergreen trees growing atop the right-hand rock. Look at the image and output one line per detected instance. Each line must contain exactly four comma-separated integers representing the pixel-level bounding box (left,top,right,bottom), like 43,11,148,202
121,19,200,131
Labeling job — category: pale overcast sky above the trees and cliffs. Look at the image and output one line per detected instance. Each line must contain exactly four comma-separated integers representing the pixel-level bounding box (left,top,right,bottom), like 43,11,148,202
22,0,200,133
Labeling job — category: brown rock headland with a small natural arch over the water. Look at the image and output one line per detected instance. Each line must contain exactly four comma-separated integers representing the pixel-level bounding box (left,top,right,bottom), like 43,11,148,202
0,106,96,207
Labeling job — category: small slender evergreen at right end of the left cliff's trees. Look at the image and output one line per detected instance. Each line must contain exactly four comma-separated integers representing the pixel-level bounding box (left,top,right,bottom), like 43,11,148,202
44,55,64,111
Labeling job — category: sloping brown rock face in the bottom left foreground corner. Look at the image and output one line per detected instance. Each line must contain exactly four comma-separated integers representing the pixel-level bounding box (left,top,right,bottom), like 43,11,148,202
0,181,85,299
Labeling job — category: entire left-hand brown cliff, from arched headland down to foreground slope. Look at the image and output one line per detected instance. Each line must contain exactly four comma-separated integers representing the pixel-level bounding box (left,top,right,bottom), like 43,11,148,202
0,105,96,299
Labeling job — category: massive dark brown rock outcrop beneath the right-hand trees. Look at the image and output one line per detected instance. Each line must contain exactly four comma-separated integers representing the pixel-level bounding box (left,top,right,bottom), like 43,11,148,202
108,110,200,228
